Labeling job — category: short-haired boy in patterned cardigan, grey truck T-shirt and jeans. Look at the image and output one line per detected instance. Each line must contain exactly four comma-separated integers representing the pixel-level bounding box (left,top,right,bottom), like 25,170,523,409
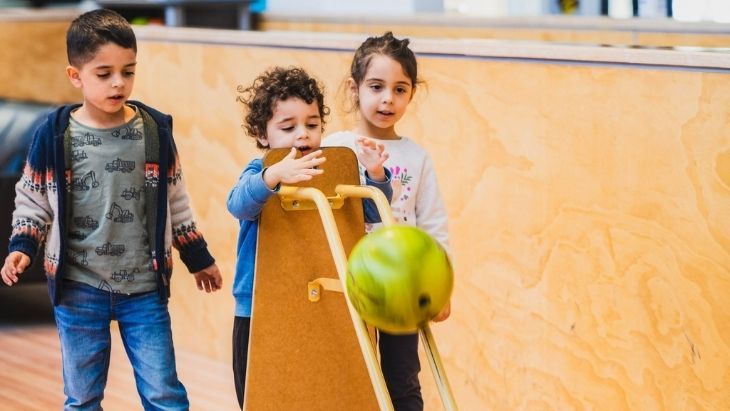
0,10,221,410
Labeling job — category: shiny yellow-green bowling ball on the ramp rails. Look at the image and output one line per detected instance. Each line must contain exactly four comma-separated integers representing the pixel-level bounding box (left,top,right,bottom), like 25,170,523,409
347,225,454,334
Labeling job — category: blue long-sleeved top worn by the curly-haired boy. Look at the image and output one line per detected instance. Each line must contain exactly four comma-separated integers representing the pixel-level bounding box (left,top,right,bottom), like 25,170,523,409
227,159,393,317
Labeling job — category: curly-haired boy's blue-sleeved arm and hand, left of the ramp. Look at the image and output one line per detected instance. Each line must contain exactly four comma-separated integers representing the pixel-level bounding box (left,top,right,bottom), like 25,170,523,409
226,148,325,221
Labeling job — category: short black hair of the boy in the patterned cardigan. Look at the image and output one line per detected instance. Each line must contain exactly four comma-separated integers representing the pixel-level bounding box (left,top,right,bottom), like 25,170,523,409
66,9,137,67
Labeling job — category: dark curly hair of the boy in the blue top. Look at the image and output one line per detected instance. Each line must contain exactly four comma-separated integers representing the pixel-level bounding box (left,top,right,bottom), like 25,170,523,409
237,67,330,148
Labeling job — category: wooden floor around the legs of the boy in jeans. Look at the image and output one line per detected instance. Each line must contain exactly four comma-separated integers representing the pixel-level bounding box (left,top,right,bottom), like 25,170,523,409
0,285,238,411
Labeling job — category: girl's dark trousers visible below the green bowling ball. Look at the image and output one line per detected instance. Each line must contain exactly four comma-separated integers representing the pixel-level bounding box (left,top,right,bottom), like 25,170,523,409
378,331,423,411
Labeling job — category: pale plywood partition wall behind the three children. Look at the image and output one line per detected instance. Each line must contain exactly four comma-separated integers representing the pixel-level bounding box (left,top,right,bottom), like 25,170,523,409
135,37,730,410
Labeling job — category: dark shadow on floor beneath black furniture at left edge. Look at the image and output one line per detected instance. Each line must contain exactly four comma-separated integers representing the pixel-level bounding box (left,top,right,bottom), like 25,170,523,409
0,283,55,329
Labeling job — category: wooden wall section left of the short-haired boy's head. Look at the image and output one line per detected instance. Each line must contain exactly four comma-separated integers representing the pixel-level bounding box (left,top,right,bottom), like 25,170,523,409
0,21,81,103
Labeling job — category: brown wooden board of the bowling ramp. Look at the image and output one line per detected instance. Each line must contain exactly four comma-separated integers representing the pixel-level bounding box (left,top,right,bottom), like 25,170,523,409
245,147,378,411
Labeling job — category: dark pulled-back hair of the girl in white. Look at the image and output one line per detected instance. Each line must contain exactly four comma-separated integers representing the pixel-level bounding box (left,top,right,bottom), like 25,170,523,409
350,31,420,91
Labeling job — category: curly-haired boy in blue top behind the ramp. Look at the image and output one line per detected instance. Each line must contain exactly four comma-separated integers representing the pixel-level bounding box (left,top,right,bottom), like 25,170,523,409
228,67,393,407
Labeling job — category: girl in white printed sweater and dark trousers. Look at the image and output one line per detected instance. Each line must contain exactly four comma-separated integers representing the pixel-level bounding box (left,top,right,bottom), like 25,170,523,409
322,32,451,411
